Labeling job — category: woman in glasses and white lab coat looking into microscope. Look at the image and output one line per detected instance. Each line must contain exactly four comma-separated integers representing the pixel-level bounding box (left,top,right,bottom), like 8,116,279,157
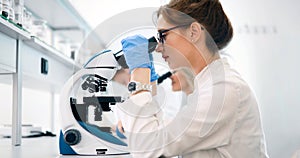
118,0,268,158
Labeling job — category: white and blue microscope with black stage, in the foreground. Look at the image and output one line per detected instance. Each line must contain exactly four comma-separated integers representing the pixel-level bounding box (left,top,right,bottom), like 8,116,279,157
59,37,157,155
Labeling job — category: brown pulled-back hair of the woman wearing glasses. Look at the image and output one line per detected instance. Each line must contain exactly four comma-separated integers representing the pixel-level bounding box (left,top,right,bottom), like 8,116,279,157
157,0,233,50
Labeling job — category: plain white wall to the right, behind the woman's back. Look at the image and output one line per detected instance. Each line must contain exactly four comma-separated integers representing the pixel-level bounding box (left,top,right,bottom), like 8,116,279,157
221,0,300,158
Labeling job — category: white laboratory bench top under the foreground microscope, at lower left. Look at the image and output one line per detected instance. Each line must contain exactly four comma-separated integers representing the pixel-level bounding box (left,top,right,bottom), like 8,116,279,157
0,137,131,158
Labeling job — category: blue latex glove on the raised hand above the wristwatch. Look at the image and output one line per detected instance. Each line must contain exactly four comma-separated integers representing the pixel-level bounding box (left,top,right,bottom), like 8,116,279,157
121,35,151,73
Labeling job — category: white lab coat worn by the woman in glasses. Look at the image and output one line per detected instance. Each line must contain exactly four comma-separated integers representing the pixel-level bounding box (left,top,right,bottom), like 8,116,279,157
118,59,268,158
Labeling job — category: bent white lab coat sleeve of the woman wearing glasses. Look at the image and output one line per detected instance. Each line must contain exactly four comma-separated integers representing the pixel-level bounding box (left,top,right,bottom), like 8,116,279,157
120,81,239,157
